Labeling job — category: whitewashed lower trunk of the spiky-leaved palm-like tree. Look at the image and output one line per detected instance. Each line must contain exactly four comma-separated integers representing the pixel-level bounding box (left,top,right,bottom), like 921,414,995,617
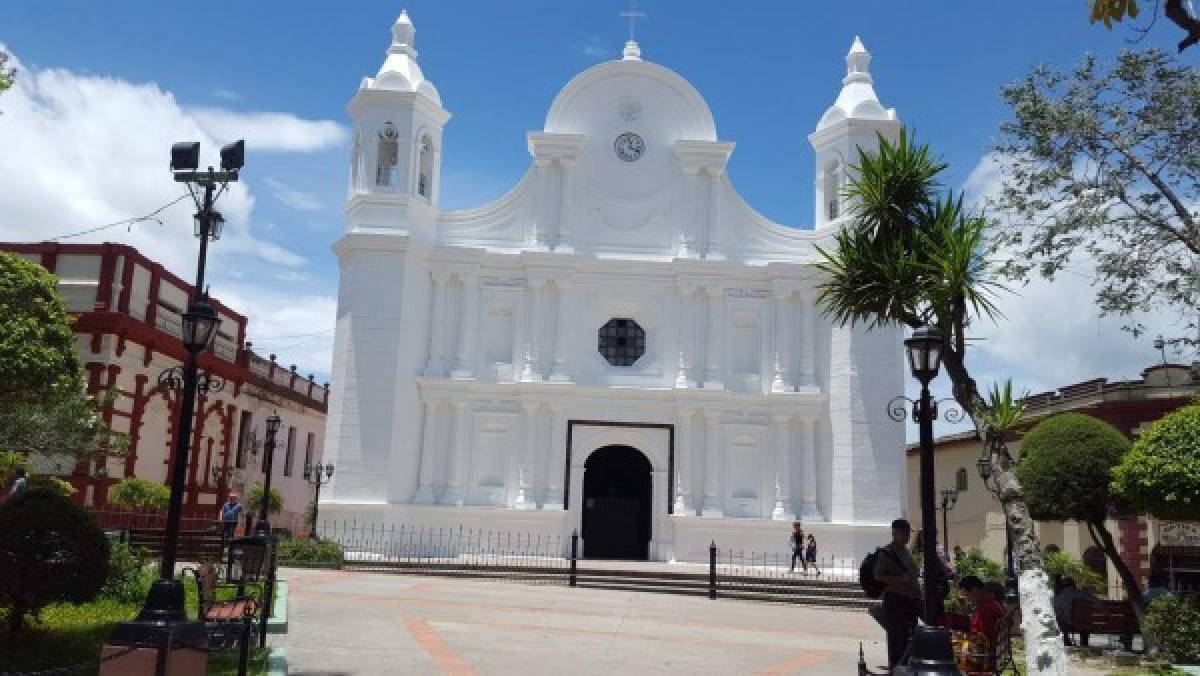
991,453,1070,676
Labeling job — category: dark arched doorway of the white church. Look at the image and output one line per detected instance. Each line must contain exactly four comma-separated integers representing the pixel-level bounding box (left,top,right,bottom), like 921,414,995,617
583,445,652,561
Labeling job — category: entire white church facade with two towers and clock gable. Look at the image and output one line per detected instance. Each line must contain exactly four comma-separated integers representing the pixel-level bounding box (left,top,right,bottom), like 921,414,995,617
320,14,905,561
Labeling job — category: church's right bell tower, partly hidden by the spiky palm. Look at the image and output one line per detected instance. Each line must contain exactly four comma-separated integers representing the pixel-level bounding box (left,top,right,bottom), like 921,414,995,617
809,37,901,229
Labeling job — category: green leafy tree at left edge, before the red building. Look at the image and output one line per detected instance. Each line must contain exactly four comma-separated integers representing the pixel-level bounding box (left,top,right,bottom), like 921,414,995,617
0,252,125,457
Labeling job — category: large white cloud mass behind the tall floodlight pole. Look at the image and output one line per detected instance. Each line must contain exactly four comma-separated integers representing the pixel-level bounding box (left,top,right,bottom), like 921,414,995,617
0,48,336,377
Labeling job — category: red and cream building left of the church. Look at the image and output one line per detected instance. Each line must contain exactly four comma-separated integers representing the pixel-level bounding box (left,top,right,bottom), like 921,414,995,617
0,243,329,526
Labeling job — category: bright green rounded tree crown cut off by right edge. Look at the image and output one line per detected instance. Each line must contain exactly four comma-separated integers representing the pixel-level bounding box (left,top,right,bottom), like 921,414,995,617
1112,405,1200,521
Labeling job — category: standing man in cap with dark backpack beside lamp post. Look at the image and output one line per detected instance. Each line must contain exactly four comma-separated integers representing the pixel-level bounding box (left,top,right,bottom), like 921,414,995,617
874,519,920,669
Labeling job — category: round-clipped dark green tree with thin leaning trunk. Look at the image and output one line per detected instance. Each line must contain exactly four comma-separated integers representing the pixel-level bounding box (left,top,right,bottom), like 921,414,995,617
1016,413,1141,606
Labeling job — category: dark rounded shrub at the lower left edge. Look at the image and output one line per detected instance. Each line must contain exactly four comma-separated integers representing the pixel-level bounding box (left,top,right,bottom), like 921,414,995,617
0,484,108,634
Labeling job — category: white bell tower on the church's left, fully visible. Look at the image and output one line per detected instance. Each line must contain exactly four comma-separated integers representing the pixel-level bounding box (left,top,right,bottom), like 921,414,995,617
347,12,450,240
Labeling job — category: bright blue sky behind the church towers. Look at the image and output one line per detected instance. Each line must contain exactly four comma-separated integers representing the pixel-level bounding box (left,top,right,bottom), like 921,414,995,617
0,0,1200,408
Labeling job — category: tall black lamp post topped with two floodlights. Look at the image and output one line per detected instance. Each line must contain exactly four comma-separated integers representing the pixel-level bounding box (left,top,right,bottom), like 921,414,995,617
101,140,245,675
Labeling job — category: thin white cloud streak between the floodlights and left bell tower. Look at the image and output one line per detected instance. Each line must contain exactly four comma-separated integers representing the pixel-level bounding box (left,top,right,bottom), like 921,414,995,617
187,106,348,152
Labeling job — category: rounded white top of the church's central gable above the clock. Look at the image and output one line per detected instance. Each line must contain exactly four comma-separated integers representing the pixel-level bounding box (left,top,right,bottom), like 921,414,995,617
545,41,716,143
